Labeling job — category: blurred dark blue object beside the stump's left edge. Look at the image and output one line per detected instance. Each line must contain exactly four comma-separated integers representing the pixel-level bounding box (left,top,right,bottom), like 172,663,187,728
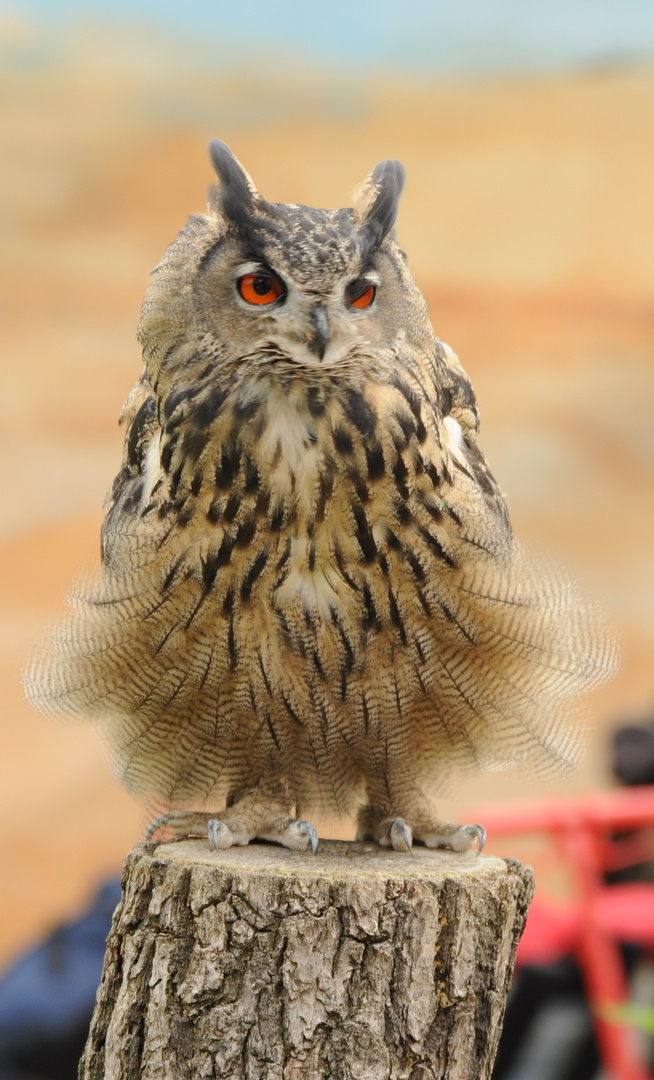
0,877,121,1080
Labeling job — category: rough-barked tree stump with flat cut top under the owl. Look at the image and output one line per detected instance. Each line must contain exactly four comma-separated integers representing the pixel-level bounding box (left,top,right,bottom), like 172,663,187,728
80,840,533,1080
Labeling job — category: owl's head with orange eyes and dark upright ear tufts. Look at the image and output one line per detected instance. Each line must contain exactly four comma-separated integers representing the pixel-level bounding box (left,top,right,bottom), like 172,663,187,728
139,139,431,386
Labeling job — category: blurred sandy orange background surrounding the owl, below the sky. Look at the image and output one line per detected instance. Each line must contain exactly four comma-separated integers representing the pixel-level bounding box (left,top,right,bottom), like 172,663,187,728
0,27,654,959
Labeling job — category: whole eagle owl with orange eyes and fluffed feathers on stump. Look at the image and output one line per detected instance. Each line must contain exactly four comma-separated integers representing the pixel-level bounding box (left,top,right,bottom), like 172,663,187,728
26,139,614,851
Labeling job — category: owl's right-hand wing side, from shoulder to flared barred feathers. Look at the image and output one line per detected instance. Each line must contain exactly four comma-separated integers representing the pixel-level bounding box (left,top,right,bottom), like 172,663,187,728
368,341,616,785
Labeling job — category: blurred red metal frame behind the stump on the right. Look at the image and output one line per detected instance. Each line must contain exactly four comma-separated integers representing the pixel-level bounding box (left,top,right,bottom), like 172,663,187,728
469,786,654,1080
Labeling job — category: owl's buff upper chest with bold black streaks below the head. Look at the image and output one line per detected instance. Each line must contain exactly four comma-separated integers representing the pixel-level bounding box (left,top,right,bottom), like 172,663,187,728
162,373,451,636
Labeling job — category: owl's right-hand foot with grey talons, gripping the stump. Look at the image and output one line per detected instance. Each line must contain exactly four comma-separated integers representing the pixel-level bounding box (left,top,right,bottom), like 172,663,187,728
357,806,486,855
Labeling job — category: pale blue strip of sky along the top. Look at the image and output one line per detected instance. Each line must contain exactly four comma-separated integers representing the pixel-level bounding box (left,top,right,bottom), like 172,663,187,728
7,0,654,75
